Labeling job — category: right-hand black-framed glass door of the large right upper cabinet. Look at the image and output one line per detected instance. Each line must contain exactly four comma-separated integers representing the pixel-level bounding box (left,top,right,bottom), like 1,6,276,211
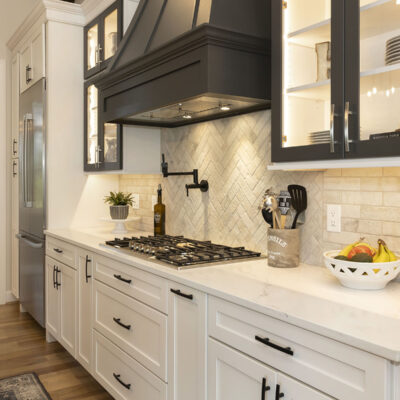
344,0,400,158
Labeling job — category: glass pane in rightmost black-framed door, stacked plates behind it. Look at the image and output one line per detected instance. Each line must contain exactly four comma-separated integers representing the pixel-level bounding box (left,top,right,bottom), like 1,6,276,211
358,0,400,143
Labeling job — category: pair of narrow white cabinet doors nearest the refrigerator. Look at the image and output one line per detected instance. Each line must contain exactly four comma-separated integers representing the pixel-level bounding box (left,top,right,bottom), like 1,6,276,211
46,257,76,356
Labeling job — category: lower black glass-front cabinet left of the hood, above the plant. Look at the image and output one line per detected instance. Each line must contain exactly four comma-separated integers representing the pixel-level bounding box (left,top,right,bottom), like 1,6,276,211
84,81,122,171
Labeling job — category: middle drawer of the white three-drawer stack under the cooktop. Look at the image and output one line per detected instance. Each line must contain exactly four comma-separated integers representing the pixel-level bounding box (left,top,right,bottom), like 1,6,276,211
94,281,167,381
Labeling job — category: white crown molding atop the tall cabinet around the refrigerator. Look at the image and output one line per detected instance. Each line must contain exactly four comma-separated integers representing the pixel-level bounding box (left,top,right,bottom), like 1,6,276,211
7,0,86,51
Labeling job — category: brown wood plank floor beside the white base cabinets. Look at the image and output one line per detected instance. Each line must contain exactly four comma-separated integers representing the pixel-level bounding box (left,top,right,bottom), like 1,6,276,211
0,303,112,400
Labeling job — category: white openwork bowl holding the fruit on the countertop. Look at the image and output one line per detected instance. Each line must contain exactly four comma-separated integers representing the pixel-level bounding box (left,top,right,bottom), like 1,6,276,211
324,250,400,290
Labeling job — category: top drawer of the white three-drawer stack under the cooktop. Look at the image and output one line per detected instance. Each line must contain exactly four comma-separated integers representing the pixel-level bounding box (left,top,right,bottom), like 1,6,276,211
94,256,168,314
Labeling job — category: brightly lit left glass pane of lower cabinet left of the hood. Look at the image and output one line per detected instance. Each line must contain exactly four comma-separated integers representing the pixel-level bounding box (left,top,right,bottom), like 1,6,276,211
86,85,98,164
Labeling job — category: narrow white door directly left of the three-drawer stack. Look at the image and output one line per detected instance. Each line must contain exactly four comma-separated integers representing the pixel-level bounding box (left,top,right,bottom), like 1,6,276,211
76,249,93,372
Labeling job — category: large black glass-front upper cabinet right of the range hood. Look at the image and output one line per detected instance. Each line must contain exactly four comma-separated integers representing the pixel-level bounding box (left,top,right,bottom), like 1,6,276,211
272,0,400,162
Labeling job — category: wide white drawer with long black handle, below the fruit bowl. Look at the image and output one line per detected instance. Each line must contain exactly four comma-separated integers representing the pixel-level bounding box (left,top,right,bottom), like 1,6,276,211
208,297,388,400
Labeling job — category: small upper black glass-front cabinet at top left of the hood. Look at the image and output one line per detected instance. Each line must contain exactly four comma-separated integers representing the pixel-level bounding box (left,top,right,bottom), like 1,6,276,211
84,0,123,79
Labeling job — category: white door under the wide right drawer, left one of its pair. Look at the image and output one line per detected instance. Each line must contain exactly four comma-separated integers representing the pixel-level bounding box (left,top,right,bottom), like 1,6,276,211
208,339,276,400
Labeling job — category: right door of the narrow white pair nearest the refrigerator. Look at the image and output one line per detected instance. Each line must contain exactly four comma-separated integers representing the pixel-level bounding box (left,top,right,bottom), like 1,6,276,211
58,263,76,357
